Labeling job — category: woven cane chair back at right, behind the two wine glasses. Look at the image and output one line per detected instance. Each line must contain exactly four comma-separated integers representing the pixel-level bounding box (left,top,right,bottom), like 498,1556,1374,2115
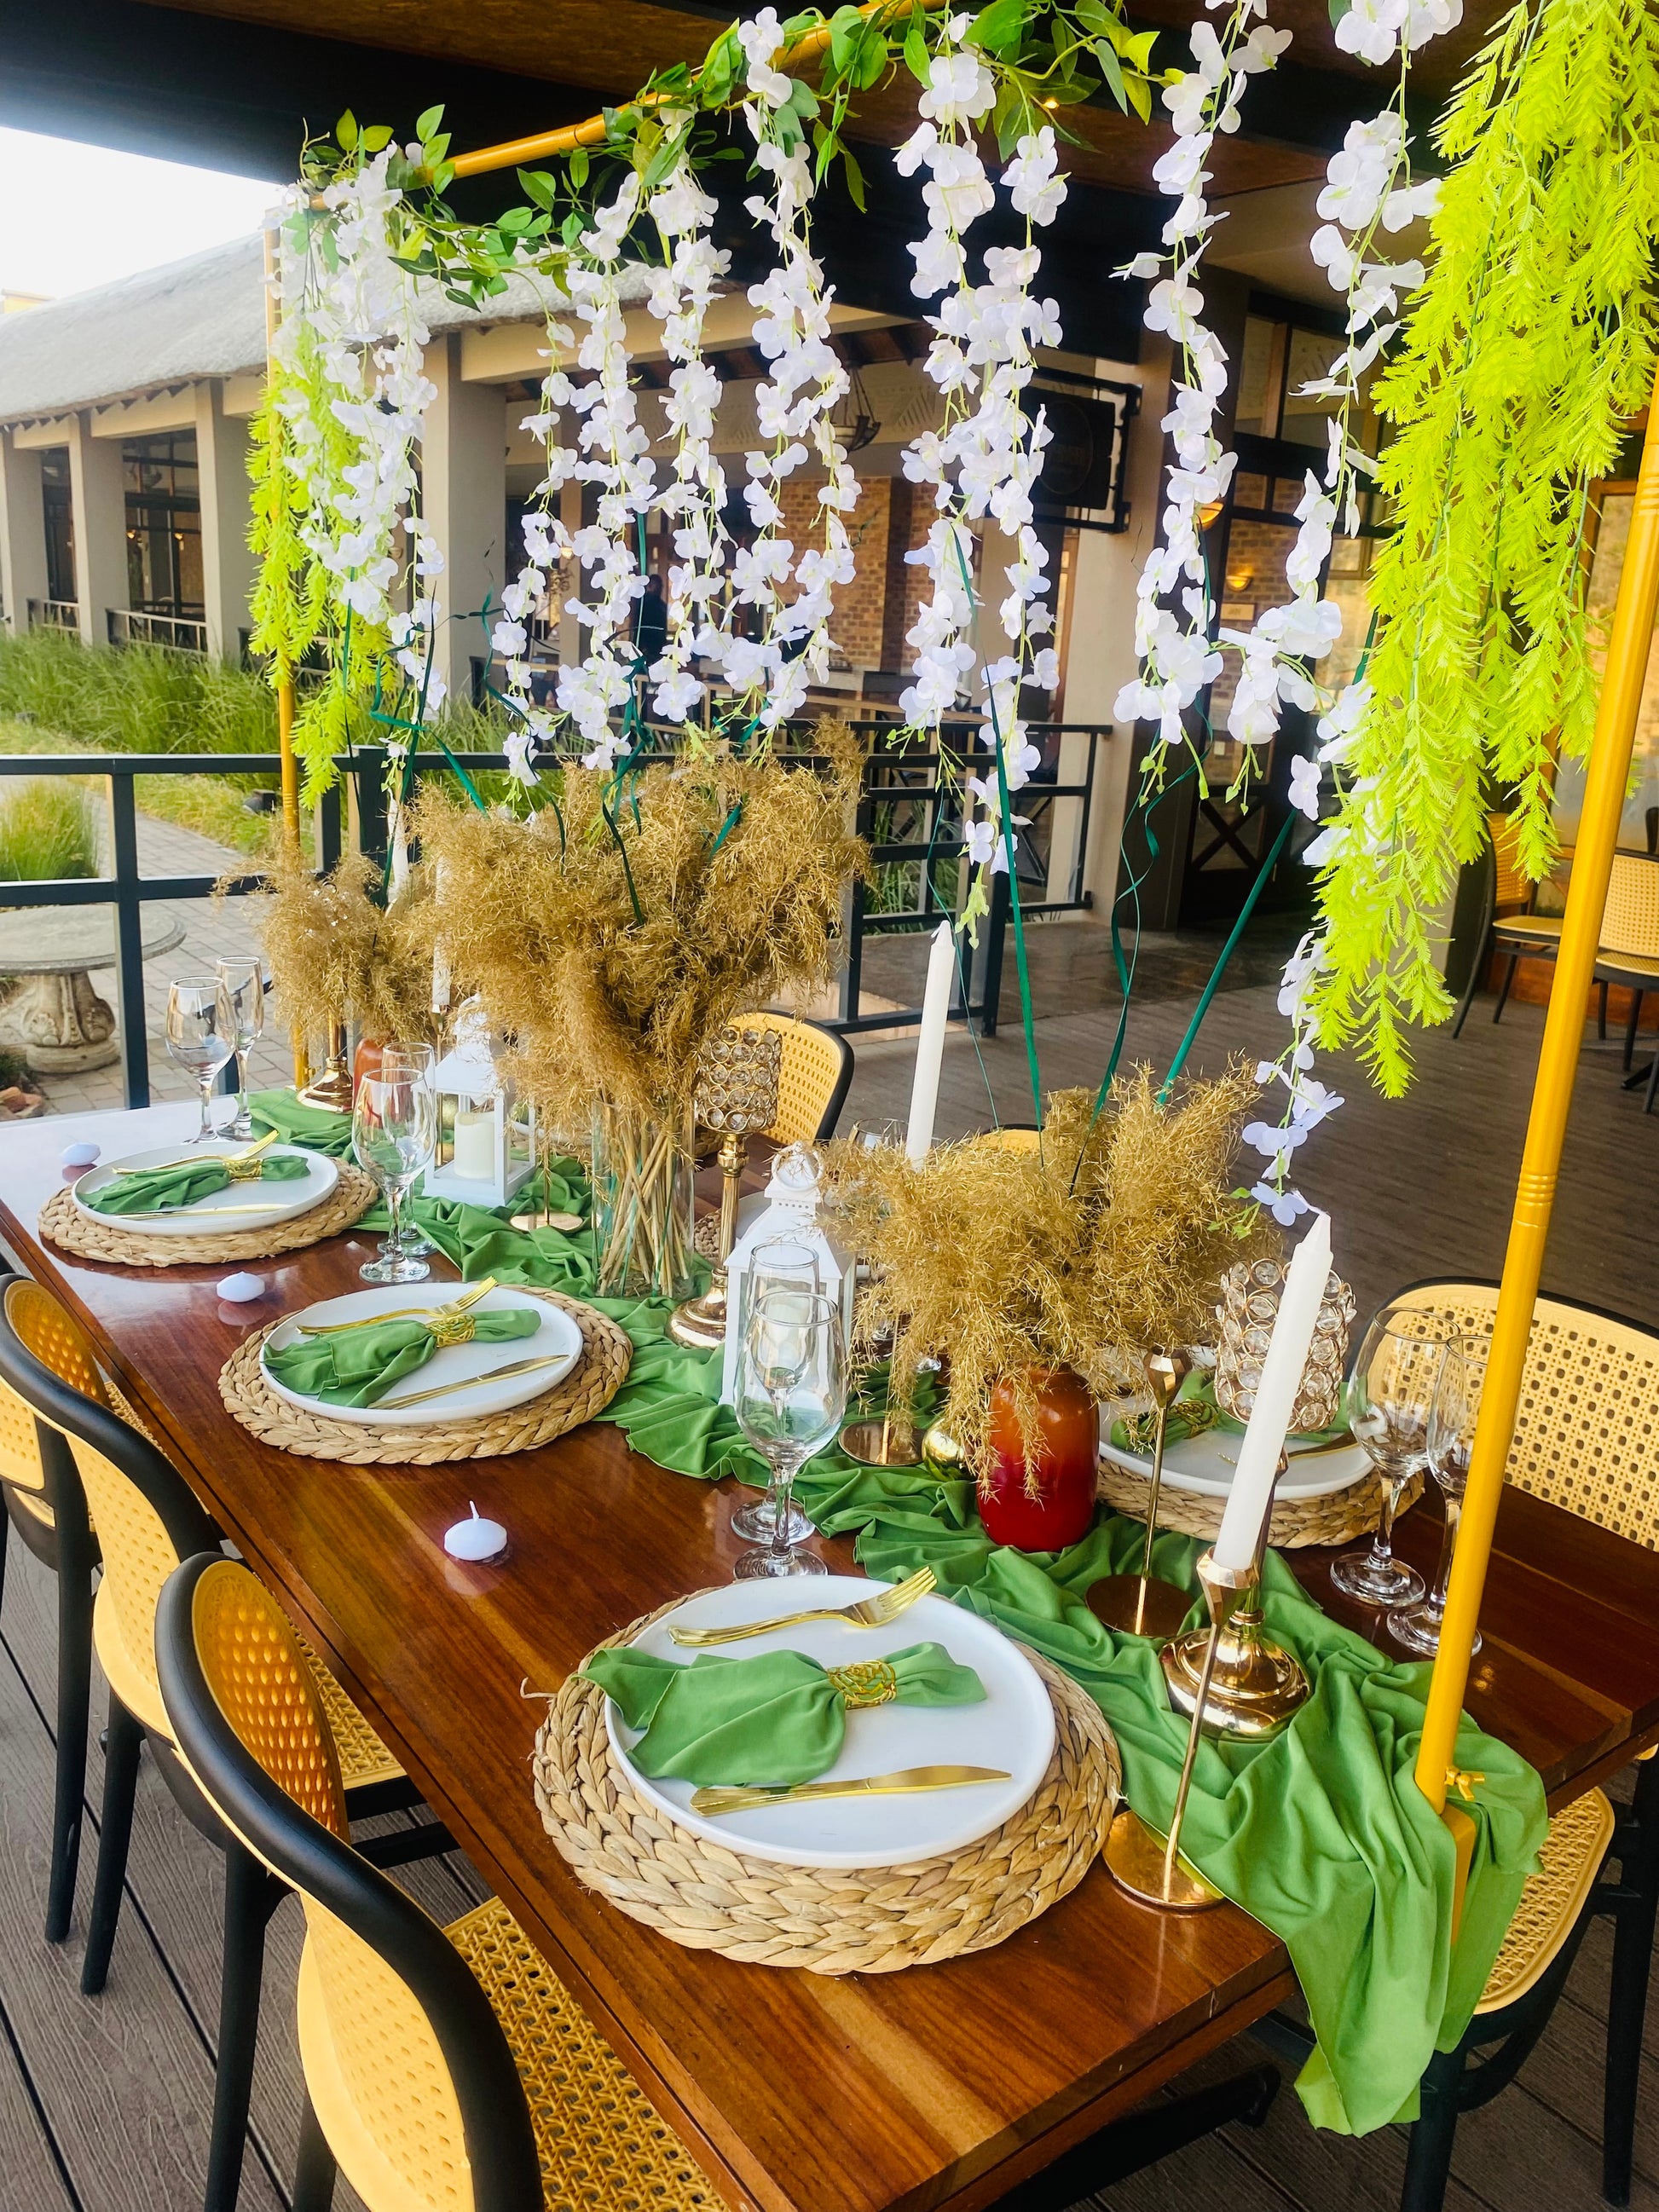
1394,1283,1659,1551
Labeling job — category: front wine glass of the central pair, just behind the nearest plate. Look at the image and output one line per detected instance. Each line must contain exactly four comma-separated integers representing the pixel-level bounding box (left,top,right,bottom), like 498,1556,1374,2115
732,1290,847,1581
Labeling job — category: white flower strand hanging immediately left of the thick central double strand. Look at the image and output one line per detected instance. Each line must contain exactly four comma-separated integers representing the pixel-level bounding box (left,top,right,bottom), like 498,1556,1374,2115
720,7,858,730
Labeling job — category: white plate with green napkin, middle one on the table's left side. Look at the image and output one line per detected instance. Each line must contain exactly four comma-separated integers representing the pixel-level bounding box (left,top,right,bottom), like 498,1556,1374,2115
259,1283,581,1429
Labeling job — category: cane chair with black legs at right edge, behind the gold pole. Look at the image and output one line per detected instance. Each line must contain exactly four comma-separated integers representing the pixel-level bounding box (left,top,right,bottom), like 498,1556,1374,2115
1396,1283,1659,2212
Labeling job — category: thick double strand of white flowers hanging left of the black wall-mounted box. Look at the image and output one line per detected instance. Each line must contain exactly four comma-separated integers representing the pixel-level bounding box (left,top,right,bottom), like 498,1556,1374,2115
898,15,1066,911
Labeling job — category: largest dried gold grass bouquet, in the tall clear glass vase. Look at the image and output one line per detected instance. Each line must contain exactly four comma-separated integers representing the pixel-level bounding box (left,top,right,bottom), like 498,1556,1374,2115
416,725,867,1115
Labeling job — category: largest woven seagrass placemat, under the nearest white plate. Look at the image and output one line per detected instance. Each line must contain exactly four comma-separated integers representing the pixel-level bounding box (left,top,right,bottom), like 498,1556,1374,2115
533,1599,1121,1973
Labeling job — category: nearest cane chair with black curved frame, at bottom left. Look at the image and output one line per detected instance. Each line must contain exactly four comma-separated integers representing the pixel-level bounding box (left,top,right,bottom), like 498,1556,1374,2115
157,1557,719,2212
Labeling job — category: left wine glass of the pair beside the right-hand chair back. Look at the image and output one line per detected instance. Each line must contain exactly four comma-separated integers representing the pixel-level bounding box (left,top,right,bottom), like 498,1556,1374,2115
1332,1305,1455,1606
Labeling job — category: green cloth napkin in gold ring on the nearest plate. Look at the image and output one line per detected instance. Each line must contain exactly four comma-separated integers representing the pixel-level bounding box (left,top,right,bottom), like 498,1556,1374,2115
581,1643,985,1789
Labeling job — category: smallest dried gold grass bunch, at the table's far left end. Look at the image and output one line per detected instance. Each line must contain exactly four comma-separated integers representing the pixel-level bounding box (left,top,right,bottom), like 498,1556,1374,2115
259,854,440,1044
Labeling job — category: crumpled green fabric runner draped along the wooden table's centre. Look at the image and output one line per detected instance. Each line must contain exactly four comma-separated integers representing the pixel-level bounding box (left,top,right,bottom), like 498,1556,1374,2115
252,1093,1546,2134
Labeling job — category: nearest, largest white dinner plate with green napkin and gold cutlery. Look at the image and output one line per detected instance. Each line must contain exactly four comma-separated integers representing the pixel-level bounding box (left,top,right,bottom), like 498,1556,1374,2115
604,1575,1055,1867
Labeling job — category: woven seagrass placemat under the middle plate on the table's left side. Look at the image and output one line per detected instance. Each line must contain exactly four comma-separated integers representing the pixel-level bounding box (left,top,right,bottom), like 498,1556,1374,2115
219,1287,633,1466
